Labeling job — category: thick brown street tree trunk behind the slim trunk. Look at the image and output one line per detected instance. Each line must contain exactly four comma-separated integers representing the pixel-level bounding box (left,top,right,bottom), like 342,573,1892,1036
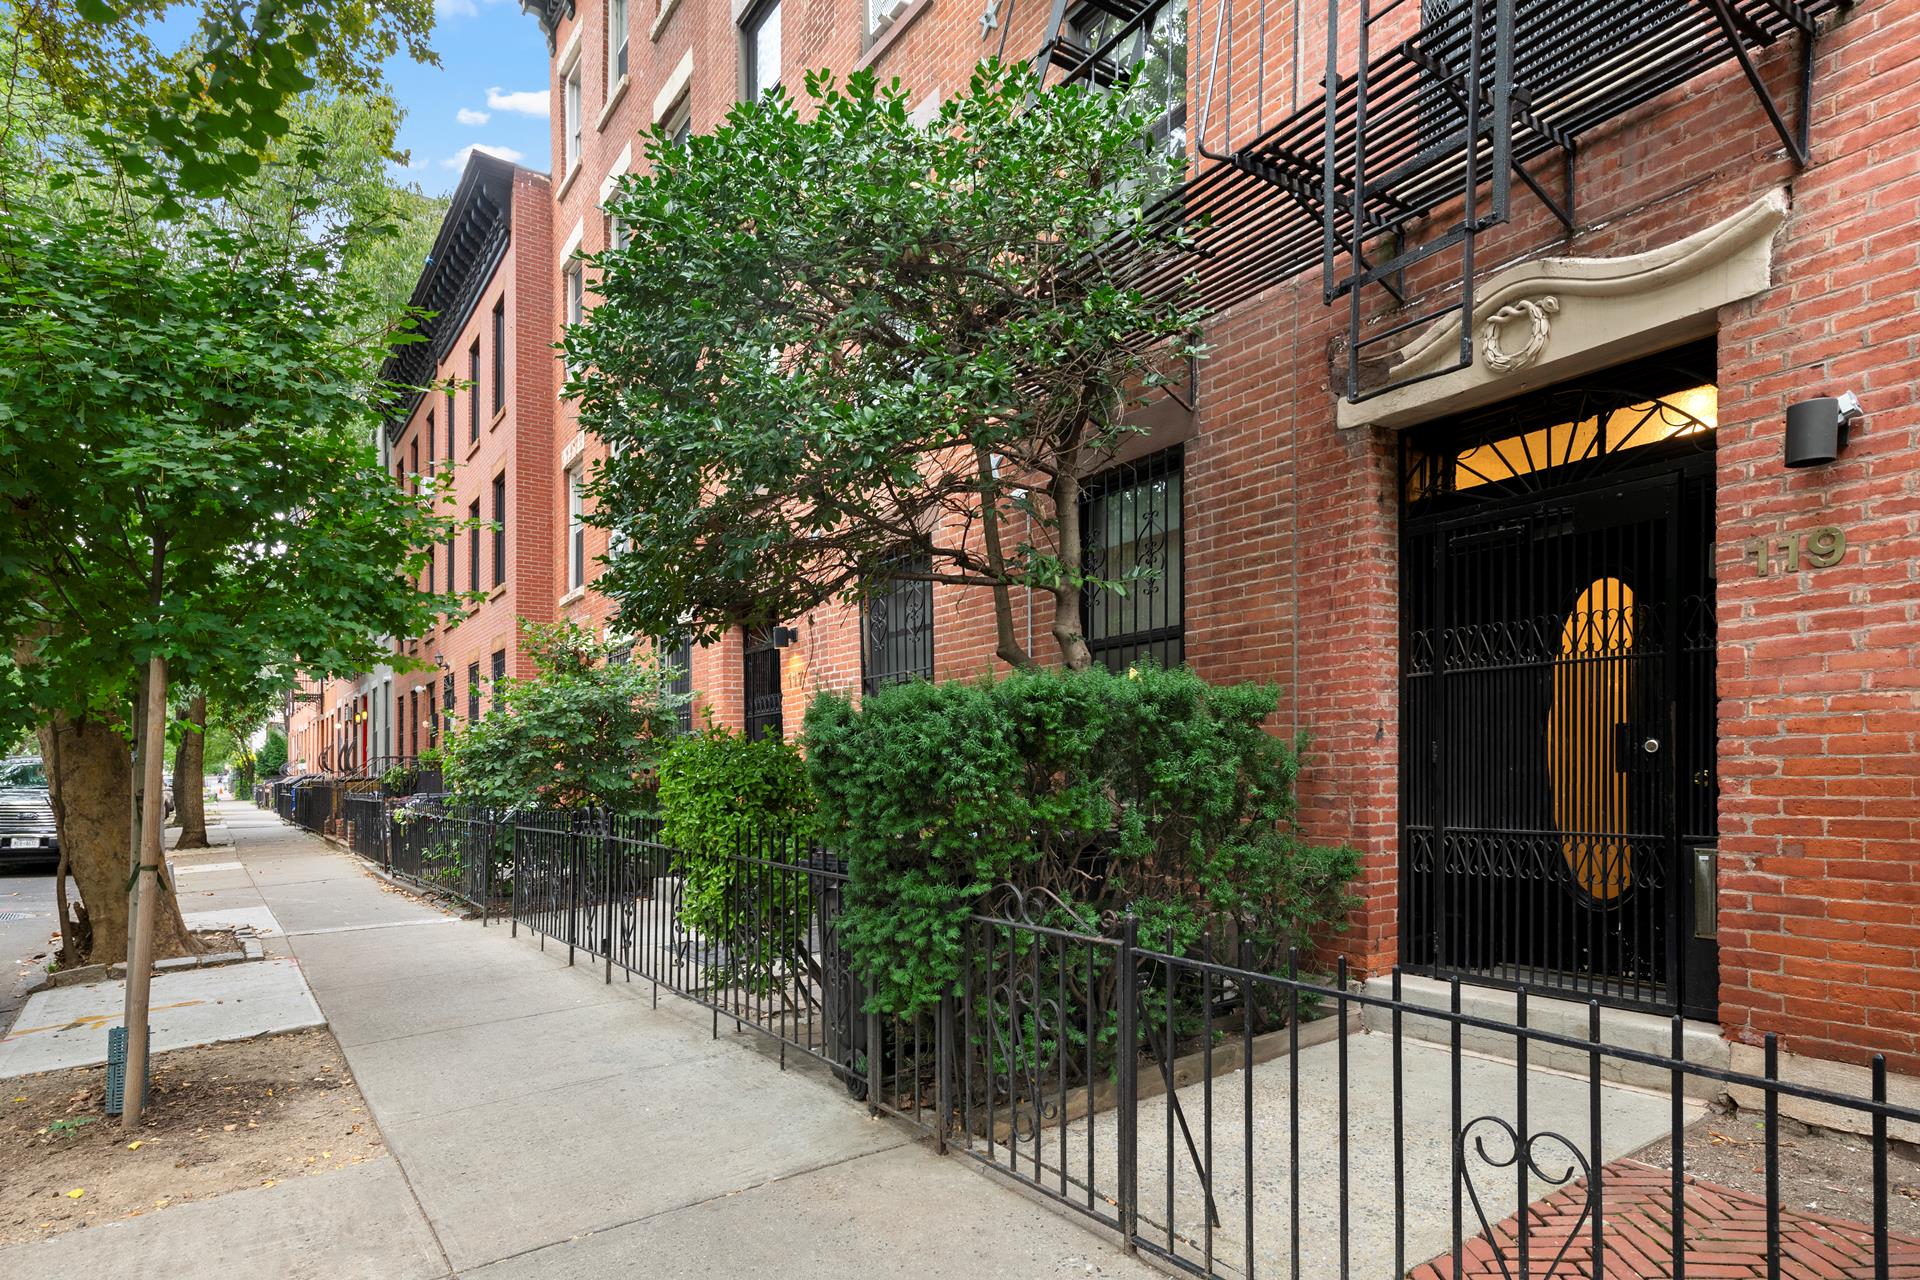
40,716,198,963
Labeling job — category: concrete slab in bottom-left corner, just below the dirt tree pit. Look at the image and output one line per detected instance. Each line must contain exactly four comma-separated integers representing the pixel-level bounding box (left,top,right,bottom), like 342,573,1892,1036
0,1155,447,1280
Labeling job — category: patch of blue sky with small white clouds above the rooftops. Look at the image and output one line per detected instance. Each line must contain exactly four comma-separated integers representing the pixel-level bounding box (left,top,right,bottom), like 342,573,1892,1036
386,0,553,196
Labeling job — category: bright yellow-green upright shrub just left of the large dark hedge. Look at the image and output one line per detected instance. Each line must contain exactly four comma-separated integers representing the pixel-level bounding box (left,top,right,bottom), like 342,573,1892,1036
659,727,814,992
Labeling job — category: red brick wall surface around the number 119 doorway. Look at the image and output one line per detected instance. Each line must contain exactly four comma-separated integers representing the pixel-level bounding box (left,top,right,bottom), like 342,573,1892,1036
464,0,1920,1071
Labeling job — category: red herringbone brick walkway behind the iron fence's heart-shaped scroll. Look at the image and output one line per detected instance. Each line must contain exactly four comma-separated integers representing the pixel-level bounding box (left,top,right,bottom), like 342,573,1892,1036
1411,1159,1920,1280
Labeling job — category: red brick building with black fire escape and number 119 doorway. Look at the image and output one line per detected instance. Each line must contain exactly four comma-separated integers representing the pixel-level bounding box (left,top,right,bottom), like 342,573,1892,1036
334,0,1920,1075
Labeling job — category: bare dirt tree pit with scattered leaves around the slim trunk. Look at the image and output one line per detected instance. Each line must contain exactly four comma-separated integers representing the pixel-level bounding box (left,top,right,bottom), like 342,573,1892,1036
0,1031,386,1245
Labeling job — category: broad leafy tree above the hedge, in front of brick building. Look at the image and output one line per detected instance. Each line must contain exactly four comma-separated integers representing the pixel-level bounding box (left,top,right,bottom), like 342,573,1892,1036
564,63,1198,668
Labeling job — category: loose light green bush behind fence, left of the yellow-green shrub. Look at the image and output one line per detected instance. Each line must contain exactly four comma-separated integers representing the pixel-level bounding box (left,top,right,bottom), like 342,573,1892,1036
442,622,685,812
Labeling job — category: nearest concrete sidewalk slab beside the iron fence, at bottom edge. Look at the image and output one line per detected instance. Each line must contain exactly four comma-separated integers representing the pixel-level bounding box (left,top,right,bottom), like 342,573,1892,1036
463,1146,1162,1280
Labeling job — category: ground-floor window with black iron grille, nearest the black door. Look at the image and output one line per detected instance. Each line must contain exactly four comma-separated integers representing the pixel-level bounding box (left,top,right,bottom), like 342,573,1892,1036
1081,447,1187,672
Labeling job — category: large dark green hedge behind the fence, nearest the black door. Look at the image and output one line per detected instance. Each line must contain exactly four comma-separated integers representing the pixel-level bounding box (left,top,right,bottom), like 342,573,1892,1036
806,666,1359,1013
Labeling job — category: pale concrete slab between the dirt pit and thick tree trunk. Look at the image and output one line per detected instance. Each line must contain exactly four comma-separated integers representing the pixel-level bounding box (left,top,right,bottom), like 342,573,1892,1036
0,960,326,1079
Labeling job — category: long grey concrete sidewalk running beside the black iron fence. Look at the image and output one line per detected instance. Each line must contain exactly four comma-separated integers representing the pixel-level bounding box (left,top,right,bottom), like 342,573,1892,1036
0,804,1158,1280
